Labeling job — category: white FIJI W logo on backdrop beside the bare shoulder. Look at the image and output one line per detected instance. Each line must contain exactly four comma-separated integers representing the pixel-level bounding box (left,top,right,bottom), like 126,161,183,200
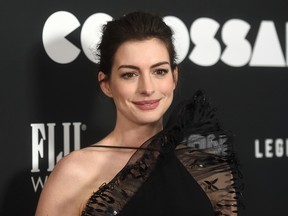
30,122,86,192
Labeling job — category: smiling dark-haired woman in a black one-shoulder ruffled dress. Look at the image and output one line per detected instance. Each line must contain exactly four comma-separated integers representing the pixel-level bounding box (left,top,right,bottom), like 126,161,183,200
36,12,237,216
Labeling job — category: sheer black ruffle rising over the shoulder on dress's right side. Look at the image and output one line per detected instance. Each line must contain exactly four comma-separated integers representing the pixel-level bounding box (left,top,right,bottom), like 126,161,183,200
165,91,243,215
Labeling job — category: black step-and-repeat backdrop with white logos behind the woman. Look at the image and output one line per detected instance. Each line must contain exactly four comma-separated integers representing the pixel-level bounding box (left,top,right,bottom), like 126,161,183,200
0,0,288,216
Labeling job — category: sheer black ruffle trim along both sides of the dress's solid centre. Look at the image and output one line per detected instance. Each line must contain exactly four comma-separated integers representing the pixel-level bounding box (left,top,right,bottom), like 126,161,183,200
82,91,242,216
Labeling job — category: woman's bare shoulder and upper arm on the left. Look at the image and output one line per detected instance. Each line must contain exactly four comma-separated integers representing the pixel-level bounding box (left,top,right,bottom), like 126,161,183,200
36,148,107,216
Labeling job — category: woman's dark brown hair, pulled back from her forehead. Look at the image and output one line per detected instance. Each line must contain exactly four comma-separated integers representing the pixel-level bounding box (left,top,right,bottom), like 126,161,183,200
97,12,176,79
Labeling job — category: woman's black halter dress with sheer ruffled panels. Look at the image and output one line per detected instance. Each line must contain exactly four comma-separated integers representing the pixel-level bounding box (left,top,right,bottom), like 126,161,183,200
82,91,238,216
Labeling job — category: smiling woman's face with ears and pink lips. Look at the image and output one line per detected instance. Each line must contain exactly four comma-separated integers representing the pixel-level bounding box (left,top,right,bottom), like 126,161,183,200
99,38,178,125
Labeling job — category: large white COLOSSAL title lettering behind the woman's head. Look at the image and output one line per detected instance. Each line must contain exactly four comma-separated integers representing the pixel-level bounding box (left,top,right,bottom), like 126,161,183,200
42,11,288,67
